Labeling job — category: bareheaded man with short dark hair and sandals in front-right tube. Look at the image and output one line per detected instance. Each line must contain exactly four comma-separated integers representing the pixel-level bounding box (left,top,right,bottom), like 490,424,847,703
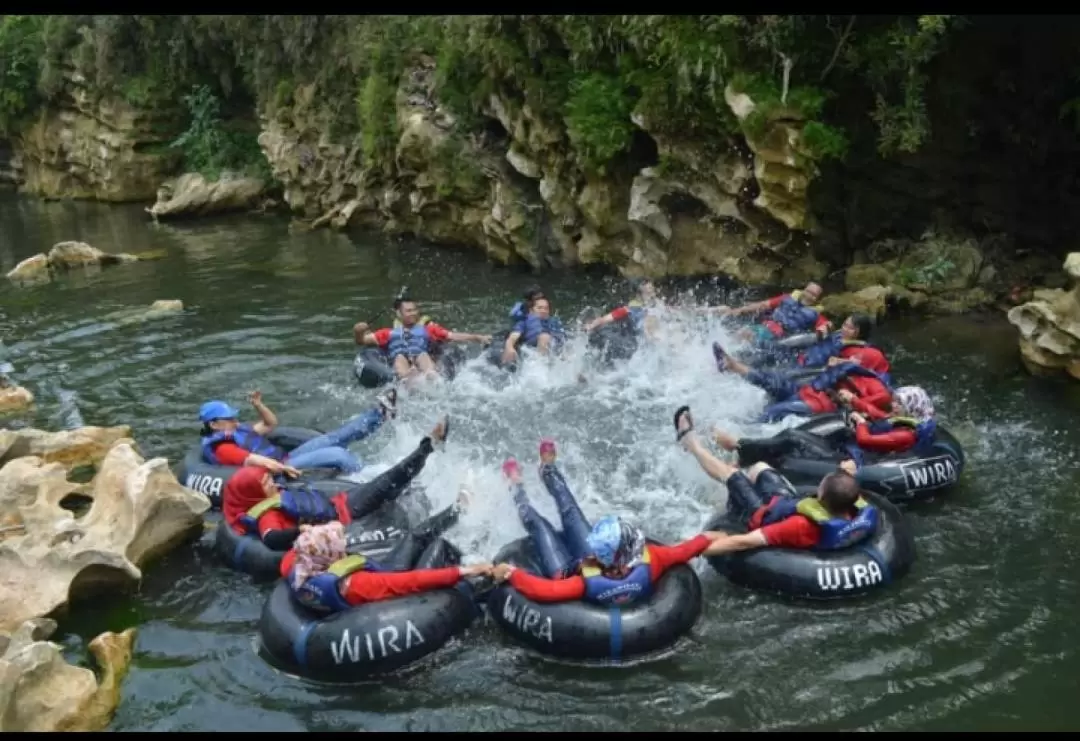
675,407,880,556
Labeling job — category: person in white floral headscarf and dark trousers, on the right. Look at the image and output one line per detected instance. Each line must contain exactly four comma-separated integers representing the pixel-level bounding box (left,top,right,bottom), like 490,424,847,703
713,386,937,470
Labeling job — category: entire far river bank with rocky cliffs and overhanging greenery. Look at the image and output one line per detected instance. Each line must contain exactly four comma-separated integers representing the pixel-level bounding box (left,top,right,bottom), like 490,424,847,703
0,16,1080,324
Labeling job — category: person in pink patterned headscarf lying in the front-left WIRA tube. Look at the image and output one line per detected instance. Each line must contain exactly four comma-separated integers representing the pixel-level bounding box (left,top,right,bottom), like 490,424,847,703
281,491,491,612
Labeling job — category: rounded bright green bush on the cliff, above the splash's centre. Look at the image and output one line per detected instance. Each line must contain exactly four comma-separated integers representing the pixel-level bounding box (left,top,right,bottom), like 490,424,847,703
565,72,636,172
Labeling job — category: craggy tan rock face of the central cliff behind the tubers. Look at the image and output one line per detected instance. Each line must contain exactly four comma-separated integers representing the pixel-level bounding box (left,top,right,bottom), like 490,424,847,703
259,63,825,282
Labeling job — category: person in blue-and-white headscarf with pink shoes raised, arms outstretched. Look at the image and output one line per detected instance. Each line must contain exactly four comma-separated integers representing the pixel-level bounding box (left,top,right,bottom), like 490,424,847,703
492,440,719,605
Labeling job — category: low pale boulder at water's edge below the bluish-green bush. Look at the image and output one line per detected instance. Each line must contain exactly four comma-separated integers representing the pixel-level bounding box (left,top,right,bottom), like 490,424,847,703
146,173,266,219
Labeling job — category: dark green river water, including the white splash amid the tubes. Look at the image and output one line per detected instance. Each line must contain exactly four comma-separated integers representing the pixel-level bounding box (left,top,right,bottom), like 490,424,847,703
0,194,1080,731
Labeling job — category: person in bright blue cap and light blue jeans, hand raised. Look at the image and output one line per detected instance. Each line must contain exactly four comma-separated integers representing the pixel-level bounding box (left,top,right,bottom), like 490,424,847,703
199,390,397,476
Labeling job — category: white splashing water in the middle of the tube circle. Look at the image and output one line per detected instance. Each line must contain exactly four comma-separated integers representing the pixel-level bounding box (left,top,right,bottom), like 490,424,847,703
332,308,780,558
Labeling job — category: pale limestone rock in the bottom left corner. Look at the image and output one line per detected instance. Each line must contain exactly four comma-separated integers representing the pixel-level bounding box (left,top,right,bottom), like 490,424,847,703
0,618,135,732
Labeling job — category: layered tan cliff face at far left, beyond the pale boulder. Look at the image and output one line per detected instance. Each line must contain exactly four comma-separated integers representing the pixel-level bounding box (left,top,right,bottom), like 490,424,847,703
10,72,179,202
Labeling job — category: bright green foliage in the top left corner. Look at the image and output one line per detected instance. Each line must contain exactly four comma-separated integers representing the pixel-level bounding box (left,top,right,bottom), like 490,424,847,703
0,15,42,134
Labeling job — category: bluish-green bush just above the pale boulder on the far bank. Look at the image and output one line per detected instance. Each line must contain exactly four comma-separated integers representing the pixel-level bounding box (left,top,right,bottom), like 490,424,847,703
170,85,269,180
